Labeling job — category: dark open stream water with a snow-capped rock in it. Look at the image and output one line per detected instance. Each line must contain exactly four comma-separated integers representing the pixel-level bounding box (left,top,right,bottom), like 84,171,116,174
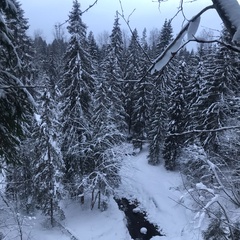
115,198,164,240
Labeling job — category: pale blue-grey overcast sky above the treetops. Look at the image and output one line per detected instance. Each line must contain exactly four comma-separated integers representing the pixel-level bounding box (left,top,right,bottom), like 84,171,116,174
20,0,225,42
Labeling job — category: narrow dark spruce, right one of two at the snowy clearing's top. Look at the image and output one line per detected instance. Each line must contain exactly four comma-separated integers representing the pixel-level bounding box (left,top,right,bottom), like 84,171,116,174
163,61,188,170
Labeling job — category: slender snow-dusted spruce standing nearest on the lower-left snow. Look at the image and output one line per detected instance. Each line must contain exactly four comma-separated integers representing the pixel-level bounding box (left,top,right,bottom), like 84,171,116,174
33,84,64,227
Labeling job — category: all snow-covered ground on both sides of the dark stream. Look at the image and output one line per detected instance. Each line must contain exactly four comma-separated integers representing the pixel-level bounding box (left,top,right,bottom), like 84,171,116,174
1,145,202,240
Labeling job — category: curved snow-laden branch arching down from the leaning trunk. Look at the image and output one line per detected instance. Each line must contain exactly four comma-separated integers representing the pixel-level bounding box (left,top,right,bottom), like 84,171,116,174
149,5,215,74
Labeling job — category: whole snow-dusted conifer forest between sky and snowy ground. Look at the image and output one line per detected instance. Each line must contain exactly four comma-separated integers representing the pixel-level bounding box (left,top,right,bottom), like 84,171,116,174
0,0,240,240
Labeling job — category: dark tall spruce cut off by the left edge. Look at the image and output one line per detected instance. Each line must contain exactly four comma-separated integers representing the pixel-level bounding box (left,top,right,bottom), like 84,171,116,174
0,0,33,165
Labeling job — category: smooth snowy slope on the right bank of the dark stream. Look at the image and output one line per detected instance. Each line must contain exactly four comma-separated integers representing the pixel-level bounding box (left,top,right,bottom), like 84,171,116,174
119,145,202,240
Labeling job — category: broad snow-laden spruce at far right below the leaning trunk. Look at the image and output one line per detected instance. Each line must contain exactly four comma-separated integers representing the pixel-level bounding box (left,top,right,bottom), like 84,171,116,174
193,38,239,152
